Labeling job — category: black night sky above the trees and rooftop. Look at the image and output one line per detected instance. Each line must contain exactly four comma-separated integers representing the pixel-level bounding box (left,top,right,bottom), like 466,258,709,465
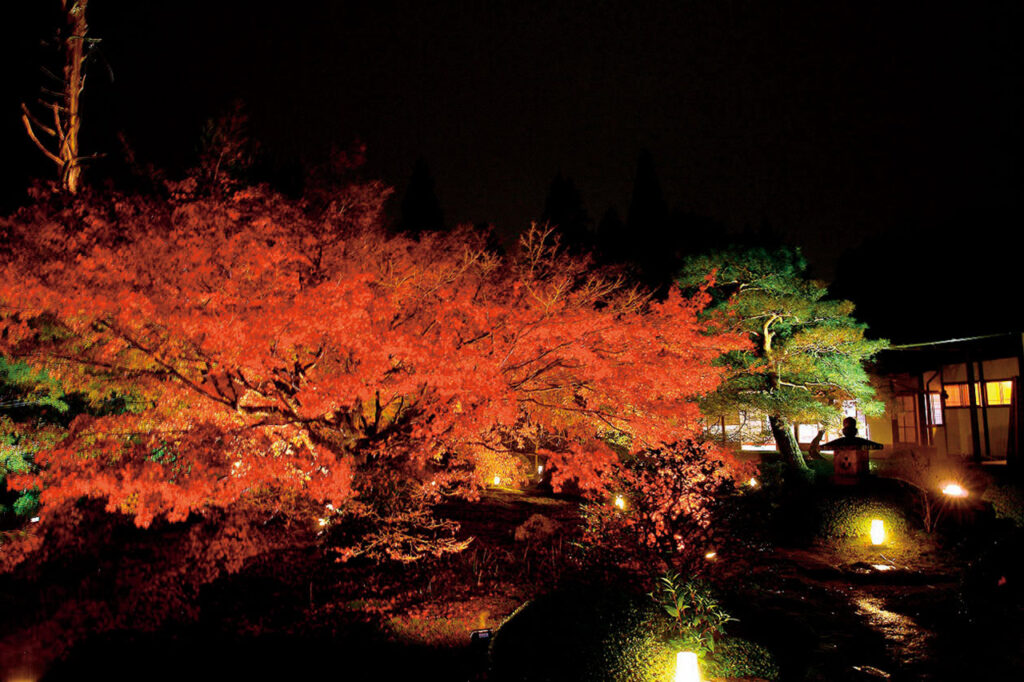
0,0,1024,337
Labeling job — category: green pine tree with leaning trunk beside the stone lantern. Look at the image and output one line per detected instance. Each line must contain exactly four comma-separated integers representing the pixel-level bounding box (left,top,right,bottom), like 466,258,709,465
678,248,888,475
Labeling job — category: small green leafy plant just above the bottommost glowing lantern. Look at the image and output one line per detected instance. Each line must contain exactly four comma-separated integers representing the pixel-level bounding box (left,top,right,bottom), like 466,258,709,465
650,572,736,657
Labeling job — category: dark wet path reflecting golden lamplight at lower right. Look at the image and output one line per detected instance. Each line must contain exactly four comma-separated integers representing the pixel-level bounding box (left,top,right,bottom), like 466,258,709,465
730,550,1021,682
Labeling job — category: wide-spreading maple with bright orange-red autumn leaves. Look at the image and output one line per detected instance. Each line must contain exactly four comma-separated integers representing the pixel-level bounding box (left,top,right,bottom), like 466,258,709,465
0,176,742,561
